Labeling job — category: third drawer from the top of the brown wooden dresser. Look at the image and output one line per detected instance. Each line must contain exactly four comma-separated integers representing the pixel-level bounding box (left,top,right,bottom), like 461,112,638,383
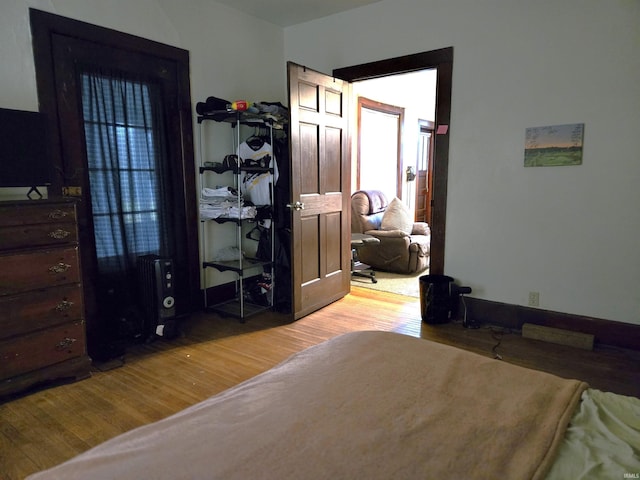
0,247,80,295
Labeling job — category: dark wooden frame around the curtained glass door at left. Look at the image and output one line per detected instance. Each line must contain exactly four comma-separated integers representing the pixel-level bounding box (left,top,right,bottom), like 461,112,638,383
29,8,200,354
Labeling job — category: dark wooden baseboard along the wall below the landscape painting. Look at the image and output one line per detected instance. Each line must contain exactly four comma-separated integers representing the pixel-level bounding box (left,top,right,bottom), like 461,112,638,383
465,297,640,350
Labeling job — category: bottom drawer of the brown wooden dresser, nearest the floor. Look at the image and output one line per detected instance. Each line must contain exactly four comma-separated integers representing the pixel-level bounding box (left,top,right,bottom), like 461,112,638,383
0,322,86,379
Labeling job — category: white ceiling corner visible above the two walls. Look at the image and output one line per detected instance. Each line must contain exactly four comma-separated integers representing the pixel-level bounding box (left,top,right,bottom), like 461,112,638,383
216,0,380,27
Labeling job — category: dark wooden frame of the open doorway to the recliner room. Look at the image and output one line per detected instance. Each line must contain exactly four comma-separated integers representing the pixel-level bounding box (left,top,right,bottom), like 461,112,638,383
333,47,453,274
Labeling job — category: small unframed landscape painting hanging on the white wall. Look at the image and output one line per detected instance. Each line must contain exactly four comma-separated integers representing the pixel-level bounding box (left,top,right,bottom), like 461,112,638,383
524,123,584,167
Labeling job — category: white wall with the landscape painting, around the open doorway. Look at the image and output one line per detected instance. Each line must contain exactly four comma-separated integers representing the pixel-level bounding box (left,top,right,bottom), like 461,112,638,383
284,0,640,324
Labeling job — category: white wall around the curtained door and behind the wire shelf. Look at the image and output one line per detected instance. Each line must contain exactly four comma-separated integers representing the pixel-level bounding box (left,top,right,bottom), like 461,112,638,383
0,0,286,285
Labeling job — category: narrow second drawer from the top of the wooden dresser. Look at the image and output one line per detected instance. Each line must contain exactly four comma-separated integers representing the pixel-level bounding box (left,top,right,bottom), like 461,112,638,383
0,222,78,250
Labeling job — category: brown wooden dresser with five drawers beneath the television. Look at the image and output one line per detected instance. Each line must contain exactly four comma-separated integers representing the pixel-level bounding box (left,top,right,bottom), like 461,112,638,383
0,200,91,399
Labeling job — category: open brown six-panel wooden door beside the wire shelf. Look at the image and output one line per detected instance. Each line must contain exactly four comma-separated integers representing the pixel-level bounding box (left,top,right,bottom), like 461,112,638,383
287,62,351,319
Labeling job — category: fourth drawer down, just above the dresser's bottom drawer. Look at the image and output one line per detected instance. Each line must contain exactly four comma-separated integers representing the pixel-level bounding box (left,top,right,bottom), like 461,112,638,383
0,284,84,339
